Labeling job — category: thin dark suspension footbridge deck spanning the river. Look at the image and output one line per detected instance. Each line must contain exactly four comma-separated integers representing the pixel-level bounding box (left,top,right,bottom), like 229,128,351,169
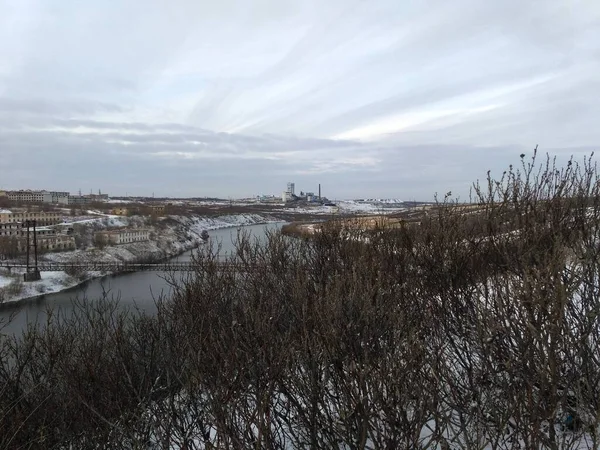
0,261,244,272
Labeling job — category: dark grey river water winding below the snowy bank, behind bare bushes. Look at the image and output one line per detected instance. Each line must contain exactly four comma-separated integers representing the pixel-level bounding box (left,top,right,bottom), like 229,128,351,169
0,223,283,334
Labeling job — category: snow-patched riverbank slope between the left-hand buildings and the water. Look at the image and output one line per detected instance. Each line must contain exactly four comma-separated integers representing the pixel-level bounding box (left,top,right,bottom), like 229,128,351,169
0,214,280,303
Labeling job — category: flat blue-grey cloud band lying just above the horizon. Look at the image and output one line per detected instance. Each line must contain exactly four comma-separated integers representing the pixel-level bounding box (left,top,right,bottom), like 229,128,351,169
0,116,586,199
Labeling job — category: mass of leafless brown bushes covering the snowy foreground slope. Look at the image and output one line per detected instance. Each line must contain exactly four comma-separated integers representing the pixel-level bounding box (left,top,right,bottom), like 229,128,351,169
0,150,600,449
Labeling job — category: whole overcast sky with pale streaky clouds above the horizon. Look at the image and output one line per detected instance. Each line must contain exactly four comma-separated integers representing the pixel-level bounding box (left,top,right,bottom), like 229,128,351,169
0,0,600,200
